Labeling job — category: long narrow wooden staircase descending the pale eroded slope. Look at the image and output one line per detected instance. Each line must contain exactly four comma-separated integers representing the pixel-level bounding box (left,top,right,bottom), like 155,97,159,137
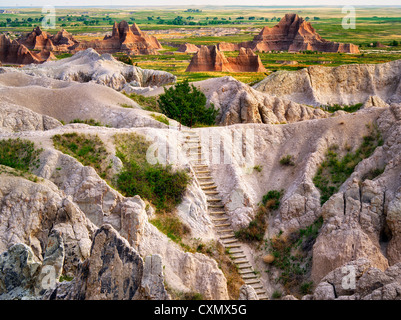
182,129,268,300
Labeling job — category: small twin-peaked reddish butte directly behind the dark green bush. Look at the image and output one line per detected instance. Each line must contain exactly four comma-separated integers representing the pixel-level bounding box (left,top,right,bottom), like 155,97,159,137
185,46,266,72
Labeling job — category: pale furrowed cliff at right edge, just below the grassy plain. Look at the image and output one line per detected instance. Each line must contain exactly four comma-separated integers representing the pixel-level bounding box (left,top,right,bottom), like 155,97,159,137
253,60,401,106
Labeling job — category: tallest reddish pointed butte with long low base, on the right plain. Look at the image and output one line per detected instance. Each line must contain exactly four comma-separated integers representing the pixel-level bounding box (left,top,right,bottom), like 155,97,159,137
219,14,359,53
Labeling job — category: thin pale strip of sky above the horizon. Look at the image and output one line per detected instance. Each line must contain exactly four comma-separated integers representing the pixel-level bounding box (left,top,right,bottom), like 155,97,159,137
0,0,401,8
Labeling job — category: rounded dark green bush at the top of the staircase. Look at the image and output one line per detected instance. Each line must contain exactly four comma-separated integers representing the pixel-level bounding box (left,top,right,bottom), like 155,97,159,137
159,79,218,127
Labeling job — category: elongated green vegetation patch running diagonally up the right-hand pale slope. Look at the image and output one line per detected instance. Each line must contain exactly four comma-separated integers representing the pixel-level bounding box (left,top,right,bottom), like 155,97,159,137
313,125,383,205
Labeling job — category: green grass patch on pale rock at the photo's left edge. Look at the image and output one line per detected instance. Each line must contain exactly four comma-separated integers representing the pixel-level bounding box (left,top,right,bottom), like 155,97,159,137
0,138,43,172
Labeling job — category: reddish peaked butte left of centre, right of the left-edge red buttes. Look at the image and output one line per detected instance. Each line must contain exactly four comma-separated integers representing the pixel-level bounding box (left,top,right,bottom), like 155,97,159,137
73,21,162,55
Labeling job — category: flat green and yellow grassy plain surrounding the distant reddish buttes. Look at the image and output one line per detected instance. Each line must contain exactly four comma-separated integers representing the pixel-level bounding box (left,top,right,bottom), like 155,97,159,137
0,6,401,84
